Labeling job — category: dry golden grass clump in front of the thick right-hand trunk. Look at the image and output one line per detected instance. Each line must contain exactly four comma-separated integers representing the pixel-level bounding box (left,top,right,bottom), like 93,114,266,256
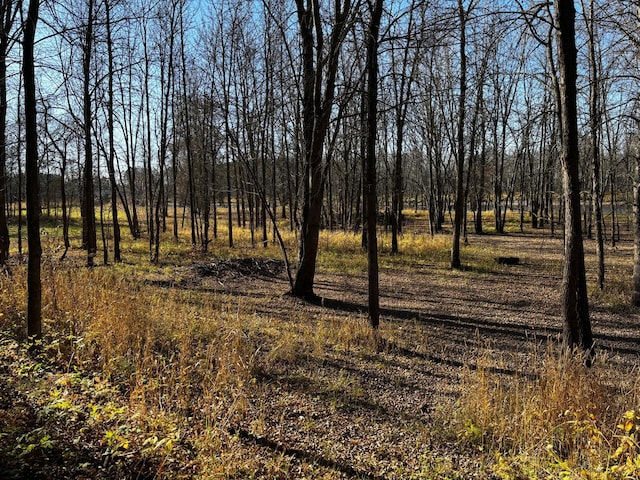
452,345,640,479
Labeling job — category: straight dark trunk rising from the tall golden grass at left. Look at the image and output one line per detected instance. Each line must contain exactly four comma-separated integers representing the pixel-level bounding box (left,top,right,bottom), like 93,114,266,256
23,0,42,338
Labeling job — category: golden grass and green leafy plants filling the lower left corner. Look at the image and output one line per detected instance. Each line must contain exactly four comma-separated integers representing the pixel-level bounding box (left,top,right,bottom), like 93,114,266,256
0,268,262,478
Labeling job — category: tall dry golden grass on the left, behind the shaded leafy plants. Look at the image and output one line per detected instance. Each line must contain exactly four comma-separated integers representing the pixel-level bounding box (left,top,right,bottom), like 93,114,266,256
0,265,264,478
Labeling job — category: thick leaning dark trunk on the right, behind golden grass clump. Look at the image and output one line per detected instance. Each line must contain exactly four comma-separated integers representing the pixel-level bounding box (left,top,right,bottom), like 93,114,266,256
555,0,593,359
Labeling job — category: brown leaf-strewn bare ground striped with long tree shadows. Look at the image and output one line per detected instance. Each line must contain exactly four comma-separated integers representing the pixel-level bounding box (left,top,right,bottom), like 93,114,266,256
188,235,640,478
